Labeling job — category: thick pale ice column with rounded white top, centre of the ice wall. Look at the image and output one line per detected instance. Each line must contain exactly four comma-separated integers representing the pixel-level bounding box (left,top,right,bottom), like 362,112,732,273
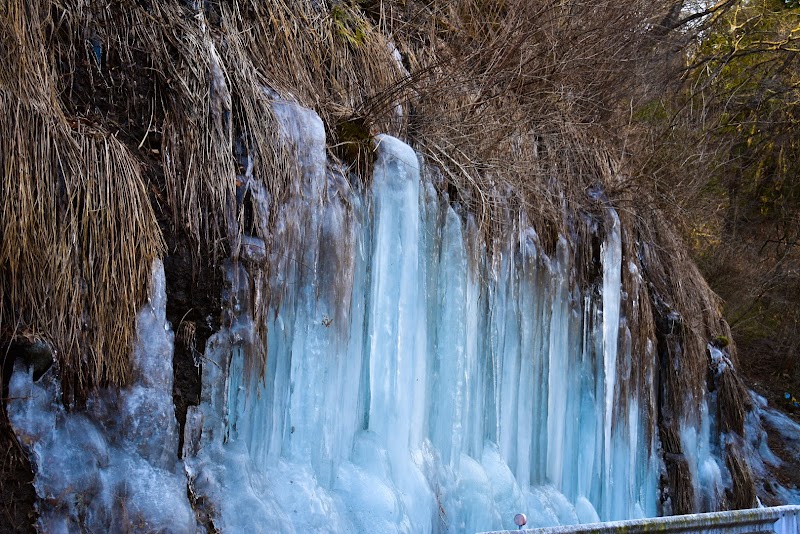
367,136,426,460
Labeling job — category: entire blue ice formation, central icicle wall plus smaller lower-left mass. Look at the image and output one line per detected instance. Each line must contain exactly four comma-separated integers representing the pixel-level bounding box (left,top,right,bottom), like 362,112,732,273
8,101,672,533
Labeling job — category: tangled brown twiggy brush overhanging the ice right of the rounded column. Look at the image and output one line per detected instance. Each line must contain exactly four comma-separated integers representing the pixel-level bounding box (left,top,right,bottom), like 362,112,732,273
350,0,680,249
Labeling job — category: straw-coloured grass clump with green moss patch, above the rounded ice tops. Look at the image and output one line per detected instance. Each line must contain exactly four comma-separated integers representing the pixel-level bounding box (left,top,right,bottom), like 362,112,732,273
228,0,406,127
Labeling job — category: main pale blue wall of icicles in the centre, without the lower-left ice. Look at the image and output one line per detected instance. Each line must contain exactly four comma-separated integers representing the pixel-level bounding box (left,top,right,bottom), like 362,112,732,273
184,102,659,533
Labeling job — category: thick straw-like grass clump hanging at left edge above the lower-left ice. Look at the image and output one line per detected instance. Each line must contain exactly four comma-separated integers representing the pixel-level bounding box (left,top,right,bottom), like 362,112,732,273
0,94,162,394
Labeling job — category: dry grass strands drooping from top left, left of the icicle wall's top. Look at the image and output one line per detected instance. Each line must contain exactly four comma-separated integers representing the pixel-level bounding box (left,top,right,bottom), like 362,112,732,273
63,0,236,255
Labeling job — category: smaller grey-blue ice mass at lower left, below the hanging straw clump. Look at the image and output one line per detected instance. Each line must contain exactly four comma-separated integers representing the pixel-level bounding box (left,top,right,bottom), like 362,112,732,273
8,263,196,533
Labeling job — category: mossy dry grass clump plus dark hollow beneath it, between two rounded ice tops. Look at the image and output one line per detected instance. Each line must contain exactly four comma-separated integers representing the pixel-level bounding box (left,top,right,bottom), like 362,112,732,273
212,0,407,184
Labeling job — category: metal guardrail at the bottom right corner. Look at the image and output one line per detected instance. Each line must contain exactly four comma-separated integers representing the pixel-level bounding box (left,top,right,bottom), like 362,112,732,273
484,506,800,534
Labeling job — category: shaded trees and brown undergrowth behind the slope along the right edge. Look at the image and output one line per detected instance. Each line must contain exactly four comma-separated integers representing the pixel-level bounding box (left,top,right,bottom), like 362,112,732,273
678,0,800,392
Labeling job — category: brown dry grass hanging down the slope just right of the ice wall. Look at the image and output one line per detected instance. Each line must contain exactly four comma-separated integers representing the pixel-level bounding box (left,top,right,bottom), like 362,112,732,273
635,204,755,513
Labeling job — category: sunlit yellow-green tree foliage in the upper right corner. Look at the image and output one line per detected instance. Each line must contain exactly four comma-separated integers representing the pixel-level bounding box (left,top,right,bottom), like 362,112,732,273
693,0,800,228
